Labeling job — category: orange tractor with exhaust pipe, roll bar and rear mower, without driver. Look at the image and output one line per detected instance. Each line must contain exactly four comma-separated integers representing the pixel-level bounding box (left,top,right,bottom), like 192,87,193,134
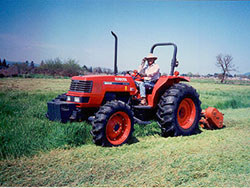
47,32,223,146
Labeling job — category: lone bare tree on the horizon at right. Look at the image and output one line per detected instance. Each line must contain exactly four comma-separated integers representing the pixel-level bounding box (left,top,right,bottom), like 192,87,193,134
215,54,236,83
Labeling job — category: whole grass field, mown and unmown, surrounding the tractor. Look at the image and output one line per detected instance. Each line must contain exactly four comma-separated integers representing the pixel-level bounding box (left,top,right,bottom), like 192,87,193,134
0,78,250,187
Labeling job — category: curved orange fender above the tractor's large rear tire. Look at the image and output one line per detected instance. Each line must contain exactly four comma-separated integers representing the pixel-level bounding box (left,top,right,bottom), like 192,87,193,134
147,76,190,108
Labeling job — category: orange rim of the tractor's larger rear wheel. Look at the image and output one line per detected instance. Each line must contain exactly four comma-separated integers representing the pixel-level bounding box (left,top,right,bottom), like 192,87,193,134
177,98,196,129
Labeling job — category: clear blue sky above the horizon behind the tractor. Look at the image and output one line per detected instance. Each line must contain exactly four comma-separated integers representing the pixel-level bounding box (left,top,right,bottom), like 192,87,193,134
0,0,250,74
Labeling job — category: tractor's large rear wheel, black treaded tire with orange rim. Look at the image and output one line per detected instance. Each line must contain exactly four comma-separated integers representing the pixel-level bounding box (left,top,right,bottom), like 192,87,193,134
156,83,201,137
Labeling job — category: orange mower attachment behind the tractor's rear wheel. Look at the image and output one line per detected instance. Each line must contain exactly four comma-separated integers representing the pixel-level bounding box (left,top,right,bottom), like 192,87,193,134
200,107,224,130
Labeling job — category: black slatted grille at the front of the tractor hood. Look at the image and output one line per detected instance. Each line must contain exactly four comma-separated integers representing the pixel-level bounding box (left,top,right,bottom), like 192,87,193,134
70,80,93,93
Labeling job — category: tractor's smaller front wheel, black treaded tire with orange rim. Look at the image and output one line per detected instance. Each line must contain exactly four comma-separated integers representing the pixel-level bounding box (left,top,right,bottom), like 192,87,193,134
91,100,134,146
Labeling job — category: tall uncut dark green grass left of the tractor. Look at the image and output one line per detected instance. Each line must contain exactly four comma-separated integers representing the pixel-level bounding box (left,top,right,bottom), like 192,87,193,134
0,91,91,158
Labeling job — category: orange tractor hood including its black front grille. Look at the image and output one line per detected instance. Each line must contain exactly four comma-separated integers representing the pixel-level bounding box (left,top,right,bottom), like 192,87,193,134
66,75,137,107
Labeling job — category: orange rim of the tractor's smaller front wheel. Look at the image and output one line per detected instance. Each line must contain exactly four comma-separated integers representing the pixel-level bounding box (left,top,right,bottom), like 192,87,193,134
106,111,131,145
